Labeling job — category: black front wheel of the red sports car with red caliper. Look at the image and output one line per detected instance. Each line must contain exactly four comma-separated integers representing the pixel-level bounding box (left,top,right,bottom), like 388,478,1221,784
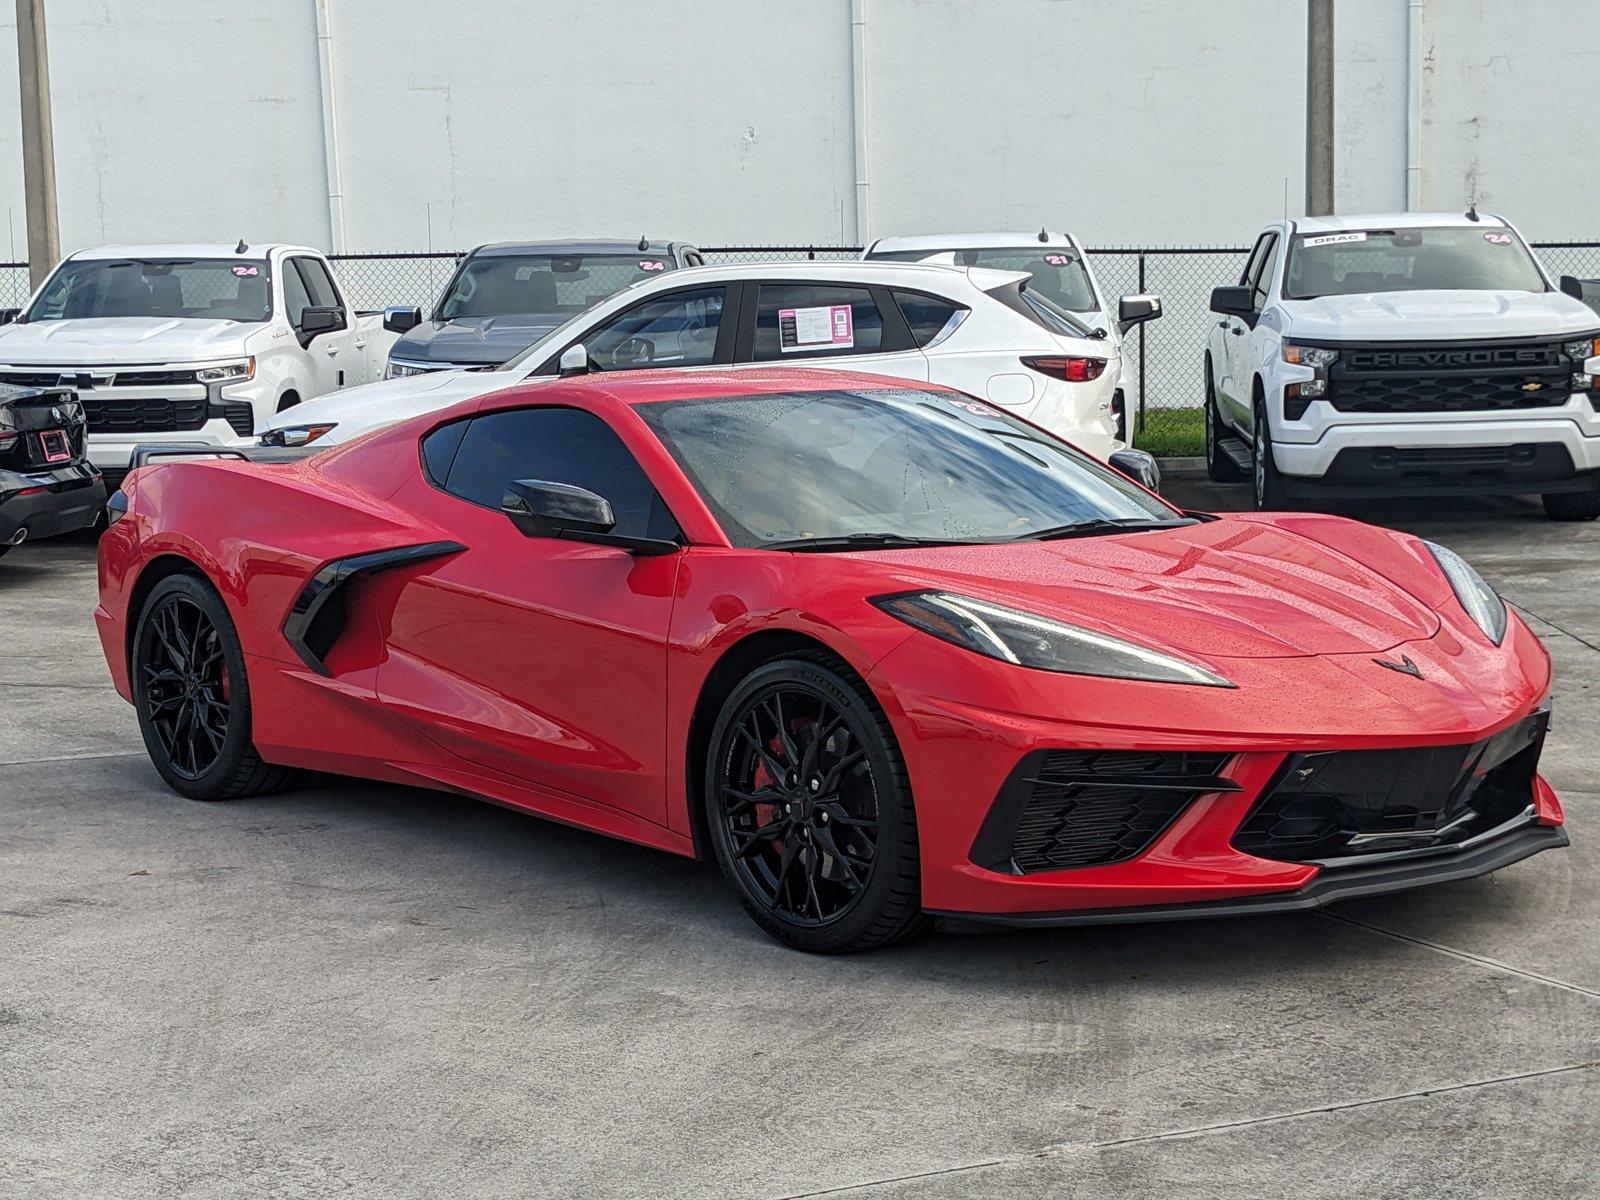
704,651,925,954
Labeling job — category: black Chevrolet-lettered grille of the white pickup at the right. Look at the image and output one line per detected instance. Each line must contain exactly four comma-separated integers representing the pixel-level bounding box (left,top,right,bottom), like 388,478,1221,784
1325,342,1573,413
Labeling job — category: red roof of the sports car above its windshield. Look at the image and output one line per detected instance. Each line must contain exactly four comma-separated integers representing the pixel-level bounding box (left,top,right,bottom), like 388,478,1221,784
478,366,950,413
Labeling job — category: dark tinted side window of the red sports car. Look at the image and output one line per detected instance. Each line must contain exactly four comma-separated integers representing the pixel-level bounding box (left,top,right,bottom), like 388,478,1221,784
435,408,678,539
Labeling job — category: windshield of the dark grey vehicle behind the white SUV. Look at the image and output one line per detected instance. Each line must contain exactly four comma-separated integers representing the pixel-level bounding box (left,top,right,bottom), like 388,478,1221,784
437,253,670,322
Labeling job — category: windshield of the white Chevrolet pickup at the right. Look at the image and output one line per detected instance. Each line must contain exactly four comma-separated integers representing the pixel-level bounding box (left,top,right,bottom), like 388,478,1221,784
1283,226,1546,299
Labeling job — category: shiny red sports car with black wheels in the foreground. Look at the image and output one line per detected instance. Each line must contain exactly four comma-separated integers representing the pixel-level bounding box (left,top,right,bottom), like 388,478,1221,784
96,370,1566,952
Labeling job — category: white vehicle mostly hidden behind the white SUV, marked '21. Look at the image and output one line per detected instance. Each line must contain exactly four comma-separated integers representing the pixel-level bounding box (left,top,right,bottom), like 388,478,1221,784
861,229,1162,438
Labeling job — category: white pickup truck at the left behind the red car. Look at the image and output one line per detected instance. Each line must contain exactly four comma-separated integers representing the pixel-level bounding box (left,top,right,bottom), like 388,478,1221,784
0,242,395,485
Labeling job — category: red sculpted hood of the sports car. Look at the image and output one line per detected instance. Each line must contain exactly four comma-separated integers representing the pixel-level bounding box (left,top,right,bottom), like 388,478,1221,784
857,520,1440,662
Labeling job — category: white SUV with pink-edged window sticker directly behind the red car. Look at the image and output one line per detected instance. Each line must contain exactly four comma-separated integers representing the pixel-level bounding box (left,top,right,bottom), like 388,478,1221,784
262,262,1154,478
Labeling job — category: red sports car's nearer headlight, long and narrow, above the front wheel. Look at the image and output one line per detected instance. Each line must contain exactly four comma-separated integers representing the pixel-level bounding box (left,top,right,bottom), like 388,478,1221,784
872,592,1234,688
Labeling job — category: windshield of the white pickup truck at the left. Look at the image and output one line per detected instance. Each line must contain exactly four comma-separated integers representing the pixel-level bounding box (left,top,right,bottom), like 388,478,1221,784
26,258,272,322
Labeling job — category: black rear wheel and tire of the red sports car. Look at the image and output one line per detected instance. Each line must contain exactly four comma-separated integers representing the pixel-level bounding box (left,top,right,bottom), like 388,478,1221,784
130,574,290,800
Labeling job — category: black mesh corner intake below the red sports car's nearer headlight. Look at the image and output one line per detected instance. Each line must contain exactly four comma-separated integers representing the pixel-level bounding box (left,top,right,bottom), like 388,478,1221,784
971,750,1238,875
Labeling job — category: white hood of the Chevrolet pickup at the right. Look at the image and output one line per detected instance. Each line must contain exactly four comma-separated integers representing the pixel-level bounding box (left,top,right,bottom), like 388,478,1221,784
1280,291,1600,341
